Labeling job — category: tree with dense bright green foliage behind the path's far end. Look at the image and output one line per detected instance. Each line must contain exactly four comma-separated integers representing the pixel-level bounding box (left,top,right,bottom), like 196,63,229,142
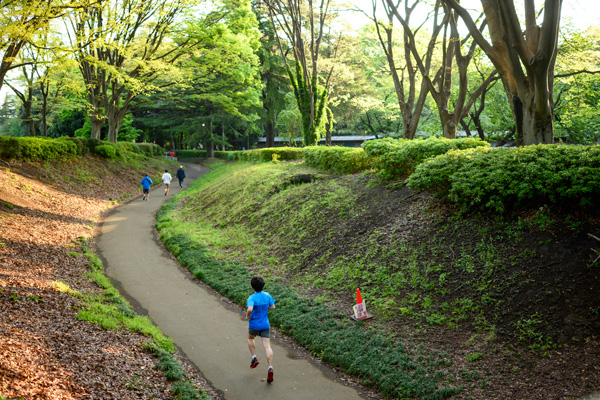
136,0,262,156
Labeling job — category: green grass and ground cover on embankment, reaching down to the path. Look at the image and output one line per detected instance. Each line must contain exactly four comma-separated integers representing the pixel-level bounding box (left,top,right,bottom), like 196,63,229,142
157,155,597,399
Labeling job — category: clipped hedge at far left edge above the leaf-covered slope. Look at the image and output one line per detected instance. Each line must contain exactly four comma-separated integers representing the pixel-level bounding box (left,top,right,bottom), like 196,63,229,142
0,136,77,161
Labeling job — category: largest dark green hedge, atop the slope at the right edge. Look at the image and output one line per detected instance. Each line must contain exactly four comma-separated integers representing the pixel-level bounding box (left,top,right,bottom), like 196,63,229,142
408,144,600,212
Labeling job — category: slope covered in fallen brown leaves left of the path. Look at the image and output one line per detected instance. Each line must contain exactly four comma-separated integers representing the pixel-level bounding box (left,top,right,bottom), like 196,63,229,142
0,158,219,399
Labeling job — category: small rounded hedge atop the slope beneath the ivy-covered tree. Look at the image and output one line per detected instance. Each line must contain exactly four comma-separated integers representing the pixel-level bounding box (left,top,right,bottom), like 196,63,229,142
302,146,372,174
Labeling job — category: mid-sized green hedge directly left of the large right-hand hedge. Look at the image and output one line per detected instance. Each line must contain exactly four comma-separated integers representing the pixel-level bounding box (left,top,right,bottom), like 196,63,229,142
364,137,490,180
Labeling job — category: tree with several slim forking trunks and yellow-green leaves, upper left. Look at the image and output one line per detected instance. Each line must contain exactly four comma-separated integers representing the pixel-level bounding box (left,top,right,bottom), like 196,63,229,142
69,0,190,142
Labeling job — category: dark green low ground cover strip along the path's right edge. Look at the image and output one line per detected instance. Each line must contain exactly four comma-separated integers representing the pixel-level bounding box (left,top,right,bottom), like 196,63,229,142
157,209,460,399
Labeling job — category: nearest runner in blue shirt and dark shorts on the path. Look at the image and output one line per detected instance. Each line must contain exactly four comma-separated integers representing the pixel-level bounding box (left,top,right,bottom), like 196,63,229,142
246,277,275,383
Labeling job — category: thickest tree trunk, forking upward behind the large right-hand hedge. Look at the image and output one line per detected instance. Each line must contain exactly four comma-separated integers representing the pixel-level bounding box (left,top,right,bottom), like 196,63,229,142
443,0,562,146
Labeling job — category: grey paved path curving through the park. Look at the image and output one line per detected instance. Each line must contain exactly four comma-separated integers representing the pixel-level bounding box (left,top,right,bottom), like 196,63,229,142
98,164,366,400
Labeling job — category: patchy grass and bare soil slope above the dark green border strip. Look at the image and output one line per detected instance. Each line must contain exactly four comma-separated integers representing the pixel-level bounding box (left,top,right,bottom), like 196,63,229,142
176,164,600,399
